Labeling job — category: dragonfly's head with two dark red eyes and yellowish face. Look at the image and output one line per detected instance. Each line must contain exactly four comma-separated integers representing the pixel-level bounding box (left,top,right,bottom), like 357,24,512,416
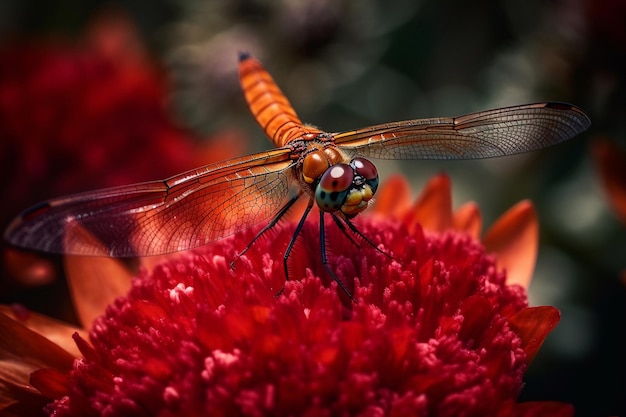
315,158,378,218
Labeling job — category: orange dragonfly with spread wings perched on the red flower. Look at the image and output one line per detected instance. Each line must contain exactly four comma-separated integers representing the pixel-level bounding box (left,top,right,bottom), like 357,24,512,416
4,53,591,294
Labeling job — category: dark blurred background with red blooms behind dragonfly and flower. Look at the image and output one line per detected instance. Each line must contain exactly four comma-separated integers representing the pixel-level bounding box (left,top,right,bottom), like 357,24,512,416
0,0,626,416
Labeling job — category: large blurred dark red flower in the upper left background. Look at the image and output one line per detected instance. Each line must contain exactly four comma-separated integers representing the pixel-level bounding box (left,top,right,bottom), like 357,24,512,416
0,13,242,281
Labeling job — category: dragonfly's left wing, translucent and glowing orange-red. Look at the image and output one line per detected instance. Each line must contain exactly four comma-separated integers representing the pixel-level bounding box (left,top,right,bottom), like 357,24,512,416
5,149,293,257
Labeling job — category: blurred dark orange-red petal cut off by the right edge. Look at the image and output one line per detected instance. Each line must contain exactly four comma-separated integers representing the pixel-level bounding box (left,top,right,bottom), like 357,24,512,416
592,139,626,223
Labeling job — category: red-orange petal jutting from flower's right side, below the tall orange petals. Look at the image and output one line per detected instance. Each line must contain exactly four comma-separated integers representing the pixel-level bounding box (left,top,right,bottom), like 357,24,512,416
509,306,561,363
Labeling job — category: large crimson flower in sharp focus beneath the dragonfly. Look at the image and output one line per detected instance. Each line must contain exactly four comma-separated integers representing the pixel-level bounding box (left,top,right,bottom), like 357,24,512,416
0,177,573,416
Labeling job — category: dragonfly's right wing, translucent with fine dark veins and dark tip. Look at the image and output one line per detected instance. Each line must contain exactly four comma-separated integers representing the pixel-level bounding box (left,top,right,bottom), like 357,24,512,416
335,103,591,159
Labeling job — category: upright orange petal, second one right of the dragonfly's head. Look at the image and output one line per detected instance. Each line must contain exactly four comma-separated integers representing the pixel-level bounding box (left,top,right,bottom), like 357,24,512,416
405,174,452,232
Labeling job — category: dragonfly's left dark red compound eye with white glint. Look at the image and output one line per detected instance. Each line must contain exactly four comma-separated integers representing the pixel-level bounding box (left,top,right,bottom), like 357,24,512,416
315,164,354,212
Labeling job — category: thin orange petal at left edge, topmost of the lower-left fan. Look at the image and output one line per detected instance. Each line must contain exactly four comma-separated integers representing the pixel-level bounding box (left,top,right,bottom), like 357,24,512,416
0,305,84,358
